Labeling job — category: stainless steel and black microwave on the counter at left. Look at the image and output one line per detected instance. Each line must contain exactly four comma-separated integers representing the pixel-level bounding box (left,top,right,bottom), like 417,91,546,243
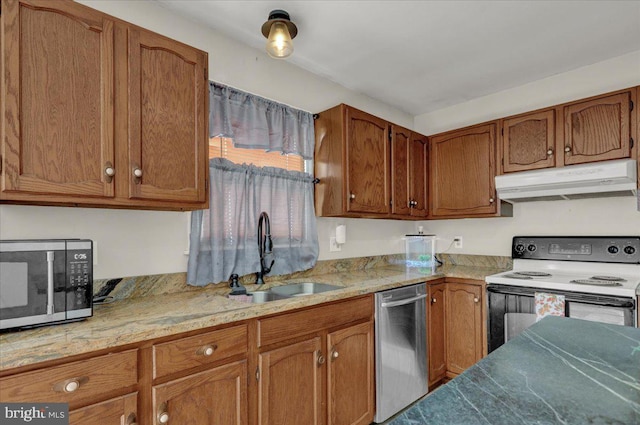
0,239,93,330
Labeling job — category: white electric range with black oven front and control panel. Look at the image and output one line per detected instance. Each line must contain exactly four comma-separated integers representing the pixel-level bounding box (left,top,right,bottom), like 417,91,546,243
485,236,640,352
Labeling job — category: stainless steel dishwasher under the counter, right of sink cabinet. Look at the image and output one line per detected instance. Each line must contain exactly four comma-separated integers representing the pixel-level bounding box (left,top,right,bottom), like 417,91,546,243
374,283,429,423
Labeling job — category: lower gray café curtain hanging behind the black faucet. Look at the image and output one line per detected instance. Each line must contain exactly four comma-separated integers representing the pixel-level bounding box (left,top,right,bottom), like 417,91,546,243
187,158,318,286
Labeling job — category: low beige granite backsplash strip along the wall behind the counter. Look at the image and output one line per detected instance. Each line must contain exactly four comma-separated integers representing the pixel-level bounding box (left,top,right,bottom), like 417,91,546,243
94,254,512,300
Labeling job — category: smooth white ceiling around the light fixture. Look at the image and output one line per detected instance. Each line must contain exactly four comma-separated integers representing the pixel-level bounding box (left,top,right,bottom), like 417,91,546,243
155,0,640,115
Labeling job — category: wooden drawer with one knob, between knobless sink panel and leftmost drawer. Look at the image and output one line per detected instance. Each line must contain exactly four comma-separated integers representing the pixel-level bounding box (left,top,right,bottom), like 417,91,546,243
153,325,248,379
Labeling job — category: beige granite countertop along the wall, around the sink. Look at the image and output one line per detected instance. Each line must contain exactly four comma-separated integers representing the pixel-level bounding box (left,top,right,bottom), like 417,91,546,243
0,266,504,371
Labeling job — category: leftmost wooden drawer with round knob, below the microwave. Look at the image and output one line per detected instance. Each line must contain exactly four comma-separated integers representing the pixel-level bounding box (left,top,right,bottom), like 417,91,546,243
0,350,138,409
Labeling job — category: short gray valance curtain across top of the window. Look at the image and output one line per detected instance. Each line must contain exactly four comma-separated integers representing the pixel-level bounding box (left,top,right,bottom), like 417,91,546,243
209,81,315,160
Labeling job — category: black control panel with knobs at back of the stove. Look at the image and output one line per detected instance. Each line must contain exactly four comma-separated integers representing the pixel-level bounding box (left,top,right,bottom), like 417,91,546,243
511,236,640,264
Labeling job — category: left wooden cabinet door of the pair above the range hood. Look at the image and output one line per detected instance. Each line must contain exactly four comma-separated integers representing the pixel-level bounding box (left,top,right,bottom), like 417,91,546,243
502,109,556,173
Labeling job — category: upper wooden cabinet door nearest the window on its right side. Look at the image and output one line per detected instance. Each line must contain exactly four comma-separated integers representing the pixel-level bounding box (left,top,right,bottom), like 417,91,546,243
345,108,390,214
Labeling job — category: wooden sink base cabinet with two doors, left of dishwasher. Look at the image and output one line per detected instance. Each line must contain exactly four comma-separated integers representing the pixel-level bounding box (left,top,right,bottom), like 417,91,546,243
256,296,375,425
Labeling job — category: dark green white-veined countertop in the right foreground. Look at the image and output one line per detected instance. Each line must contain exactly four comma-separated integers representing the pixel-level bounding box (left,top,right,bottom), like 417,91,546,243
389,316,640,425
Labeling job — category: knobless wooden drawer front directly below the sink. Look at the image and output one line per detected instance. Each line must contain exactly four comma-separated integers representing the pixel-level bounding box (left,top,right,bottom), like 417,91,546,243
258,295,373,347
